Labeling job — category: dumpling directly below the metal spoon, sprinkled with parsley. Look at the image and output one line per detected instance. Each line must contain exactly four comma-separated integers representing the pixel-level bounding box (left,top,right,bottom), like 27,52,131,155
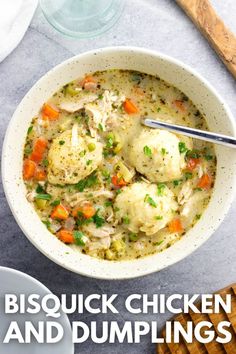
128,129,192,182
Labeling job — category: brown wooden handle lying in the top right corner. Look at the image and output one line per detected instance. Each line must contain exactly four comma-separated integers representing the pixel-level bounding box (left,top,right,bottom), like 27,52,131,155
176,0,236,78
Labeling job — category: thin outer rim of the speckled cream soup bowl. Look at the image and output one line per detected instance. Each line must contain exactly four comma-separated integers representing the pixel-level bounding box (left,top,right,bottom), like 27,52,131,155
1,46,236,280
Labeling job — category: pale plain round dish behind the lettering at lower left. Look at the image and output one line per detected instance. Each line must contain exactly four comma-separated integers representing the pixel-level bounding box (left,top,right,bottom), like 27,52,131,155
0,267,74,354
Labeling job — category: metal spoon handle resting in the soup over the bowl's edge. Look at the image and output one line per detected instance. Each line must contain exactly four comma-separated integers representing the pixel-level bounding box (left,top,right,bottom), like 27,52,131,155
142,118,236,148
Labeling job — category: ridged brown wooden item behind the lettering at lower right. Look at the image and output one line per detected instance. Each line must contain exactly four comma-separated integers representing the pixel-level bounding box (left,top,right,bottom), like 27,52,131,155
157,284,236,354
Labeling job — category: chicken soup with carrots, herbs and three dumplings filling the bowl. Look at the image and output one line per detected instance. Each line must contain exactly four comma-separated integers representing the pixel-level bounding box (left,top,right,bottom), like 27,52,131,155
23,70,216,260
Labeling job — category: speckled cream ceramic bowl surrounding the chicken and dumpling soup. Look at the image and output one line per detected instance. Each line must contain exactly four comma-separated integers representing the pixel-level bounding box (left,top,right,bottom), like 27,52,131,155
2,47,236,279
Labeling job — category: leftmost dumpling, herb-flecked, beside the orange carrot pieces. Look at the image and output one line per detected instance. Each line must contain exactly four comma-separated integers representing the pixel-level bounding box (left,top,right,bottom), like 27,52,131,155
48,125,103,185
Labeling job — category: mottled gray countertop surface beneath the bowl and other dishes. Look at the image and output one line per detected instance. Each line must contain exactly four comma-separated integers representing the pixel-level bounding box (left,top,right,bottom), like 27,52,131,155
0,0,236,354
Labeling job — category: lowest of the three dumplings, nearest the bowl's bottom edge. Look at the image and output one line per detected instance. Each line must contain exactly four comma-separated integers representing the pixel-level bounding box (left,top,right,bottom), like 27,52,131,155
114,182,178,235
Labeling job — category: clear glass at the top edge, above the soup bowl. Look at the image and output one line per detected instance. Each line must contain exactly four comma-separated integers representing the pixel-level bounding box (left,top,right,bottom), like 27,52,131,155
40,0,125,38
